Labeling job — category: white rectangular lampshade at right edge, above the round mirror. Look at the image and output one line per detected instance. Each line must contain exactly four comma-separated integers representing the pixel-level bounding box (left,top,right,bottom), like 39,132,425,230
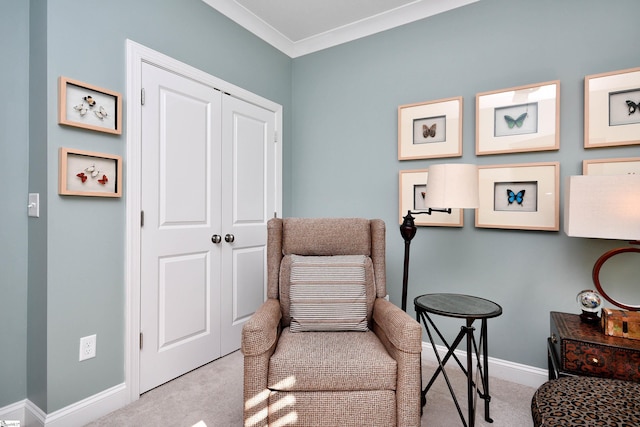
564,175,640,240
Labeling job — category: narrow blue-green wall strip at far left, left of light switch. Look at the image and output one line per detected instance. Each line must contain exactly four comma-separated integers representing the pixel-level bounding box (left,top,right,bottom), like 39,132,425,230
0,1,29,407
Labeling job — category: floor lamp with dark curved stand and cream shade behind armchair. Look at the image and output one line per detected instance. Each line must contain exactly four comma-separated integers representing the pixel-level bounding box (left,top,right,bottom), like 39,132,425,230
400,163,478,311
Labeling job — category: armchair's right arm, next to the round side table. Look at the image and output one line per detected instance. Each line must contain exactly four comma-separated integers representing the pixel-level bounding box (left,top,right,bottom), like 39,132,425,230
373,298,422,353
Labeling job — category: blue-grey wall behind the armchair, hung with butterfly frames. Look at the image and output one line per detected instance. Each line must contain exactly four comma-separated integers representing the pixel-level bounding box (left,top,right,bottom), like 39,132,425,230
289,0,640,368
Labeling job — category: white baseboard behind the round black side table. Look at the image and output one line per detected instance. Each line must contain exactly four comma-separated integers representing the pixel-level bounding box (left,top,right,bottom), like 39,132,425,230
422,341,549,388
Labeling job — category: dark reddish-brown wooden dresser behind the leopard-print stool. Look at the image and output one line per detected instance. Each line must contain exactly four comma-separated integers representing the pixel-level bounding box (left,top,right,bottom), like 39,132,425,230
547,311,640,382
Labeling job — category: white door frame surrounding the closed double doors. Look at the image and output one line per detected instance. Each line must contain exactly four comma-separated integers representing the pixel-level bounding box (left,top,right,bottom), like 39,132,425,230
124,40,282,402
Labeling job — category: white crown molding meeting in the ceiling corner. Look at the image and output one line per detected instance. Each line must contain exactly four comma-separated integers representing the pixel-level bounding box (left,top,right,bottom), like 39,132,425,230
202,0,479,58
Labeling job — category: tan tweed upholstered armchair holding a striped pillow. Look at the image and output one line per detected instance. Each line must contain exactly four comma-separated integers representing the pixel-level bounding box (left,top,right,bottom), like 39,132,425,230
242,218,422,427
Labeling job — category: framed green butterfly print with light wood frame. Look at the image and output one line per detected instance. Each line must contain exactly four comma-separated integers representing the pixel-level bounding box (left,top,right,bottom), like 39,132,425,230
476,80,560,156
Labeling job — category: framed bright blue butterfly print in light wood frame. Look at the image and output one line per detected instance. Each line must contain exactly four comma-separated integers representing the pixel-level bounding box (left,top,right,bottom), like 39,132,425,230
476,162,560,231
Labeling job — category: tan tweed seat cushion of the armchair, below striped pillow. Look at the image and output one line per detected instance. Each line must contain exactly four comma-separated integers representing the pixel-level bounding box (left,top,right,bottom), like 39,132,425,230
268,328,397,391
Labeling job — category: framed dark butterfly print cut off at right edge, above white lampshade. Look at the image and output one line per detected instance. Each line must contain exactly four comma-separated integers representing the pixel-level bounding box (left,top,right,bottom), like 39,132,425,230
584,68,640,148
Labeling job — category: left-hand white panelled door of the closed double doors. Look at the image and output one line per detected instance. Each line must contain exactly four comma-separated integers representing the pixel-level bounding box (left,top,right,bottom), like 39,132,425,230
140,64,221,392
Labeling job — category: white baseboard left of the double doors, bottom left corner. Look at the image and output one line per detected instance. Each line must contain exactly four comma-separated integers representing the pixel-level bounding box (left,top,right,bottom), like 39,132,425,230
0,383,129,427
